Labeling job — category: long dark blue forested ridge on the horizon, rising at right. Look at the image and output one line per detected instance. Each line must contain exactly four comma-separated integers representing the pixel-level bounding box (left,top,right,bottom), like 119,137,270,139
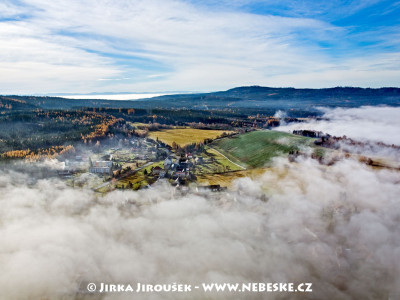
141,86,400,110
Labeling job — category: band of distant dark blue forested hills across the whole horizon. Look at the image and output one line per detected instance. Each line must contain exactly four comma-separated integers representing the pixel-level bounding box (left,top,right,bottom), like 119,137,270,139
0,86,400,112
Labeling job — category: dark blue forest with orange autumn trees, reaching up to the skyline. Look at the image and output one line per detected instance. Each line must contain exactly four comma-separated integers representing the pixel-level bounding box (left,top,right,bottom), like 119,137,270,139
0,86,400,159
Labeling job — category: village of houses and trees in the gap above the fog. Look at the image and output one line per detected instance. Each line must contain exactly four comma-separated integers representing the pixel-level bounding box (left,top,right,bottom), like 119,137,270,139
58,132,231,193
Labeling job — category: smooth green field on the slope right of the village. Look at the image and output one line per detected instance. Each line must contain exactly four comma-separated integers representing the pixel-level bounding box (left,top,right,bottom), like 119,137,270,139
211,130,313,168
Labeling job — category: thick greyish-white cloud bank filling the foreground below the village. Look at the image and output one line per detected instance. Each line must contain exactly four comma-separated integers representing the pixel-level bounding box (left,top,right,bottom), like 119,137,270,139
0,159,400,300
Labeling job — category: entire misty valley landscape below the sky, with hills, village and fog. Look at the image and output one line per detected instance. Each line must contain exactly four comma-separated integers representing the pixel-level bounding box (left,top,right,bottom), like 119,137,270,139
0,87,400,299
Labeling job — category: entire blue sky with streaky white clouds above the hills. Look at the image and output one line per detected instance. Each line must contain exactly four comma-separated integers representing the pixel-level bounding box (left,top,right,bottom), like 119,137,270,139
0,0,400,94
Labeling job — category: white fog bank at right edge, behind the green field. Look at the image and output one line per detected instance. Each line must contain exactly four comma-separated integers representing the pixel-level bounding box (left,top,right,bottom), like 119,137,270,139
275,106,400,162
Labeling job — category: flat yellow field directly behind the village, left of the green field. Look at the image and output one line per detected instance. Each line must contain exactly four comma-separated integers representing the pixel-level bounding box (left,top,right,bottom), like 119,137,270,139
149,128,232,147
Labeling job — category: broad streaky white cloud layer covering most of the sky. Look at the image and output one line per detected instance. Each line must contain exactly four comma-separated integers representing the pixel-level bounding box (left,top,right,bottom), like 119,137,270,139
0,0,400,93
